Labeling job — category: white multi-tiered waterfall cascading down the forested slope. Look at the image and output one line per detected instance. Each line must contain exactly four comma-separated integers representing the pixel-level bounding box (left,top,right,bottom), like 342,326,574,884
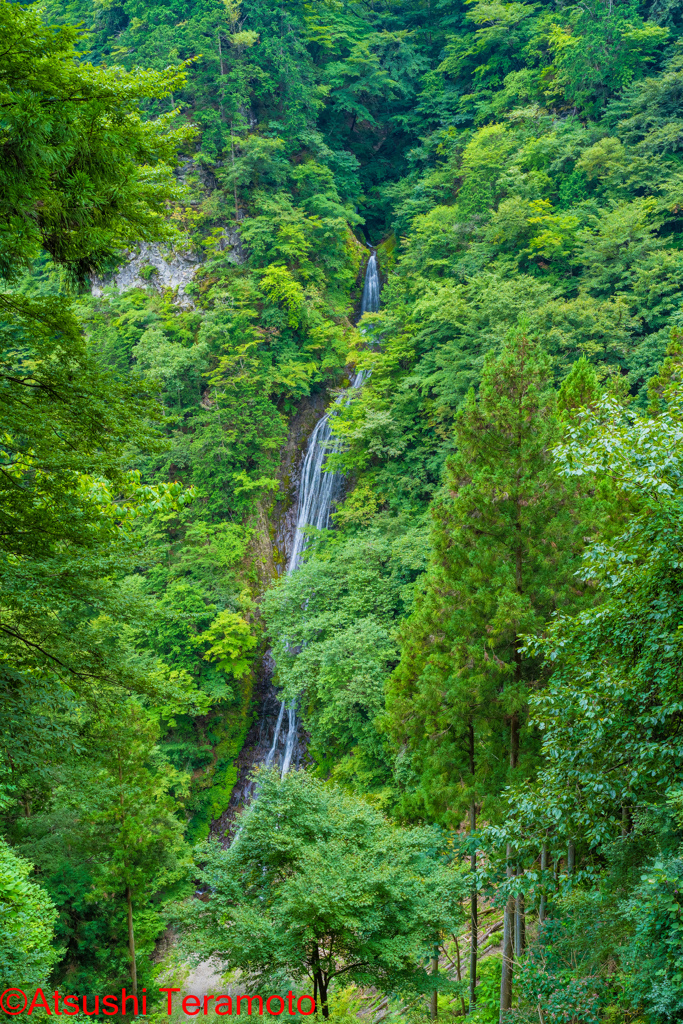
265,250,380,776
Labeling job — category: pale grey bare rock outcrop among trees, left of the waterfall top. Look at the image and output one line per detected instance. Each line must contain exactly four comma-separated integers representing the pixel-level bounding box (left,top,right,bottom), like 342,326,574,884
91,243,201,308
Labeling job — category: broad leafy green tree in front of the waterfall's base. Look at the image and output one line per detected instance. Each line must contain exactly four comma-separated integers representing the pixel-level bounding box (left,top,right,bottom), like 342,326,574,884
187,771,464,1002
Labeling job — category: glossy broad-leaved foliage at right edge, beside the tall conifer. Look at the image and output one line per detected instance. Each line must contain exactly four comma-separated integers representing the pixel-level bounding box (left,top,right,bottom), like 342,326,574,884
499,391,683,847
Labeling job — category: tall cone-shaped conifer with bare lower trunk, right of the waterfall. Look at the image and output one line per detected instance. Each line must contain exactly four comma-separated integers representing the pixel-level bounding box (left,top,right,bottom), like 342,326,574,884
388,330,588,1009
